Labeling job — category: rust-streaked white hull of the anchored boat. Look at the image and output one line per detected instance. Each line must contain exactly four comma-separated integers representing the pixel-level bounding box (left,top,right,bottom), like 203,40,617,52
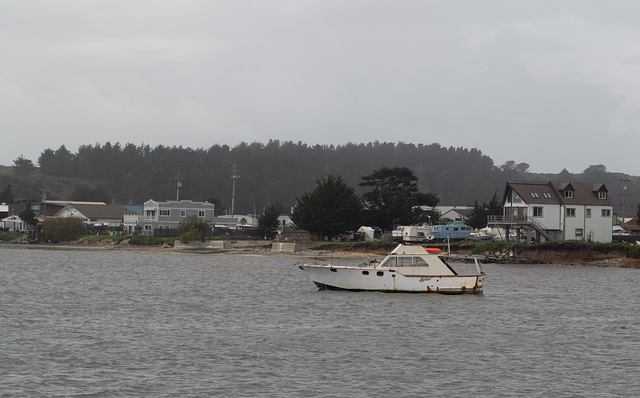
300,264,484,294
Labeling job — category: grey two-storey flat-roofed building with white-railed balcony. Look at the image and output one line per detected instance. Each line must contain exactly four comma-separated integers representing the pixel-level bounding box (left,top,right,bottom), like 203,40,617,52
123,199,215,236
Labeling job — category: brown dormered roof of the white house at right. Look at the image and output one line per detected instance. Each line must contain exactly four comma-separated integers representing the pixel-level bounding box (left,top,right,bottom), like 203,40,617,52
503,181,613,206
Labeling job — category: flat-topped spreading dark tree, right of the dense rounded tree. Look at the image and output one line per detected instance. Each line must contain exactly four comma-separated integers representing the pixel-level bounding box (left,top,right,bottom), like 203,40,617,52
359,167,439,230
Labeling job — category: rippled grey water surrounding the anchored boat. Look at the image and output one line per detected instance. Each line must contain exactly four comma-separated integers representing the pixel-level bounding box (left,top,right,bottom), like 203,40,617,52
0,248,640,397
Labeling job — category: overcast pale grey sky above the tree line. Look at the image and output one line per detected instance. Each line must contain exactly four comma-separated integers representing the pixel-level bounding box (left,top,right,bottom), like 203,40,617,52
0,0,640,175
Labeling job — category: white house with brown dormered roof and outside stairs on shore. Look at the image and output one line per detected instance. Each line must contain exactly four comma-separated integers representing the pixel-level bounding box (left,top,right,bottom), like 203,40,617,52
488,181,613,242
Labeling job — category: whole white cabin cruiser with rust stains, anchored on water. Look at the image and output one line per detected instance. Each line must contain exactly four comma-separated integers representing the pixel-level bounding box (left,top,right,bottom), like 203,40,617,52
300,244,485,294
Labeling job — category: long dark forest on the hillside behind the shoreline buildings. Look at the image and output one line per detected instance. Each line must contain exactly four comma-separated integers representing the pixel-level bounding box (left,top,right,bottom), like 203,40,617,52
0,140,640,219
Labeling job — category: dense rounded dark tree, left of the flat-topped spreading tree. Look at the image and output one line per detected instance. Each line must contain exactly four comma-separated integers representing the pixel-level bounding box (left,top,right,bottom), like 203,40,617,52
291,175,362,239
